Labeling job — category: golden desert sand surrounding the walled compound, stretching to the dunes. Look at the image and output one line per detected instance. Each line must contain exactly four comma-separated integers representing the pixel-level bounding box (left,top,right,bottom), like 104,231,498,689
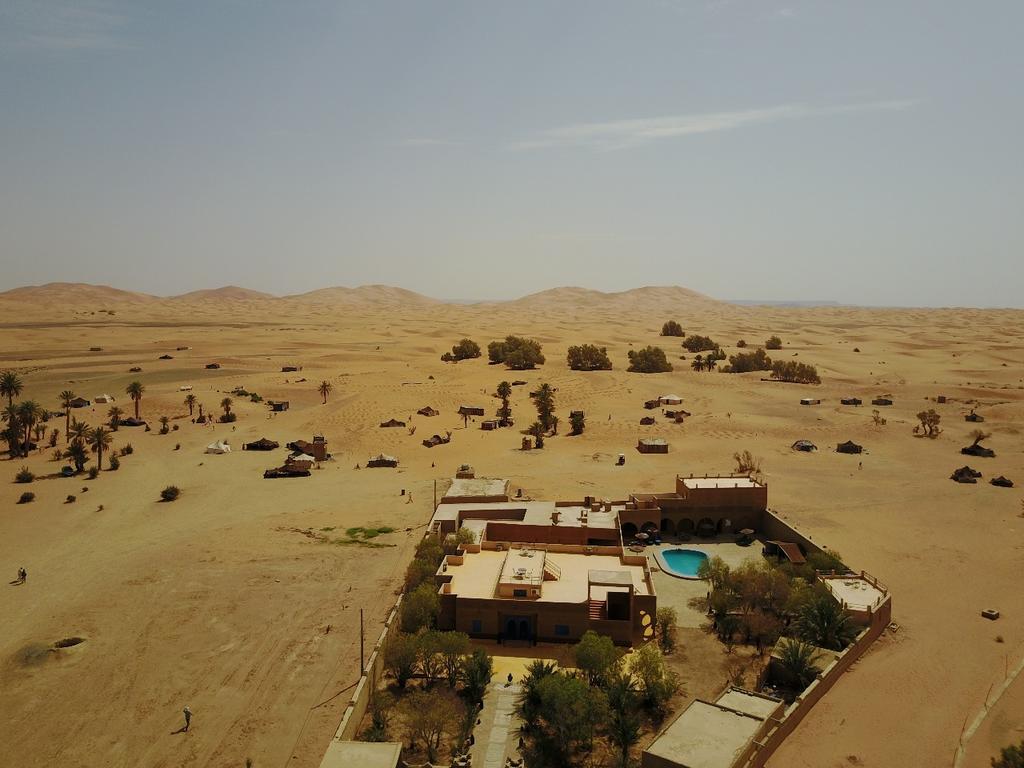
0,285,1024,768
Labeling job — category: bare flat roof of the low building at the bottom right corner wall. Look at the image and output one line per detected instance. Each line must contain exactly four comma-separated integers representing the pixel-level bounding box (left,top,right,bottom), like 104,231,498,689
645,699,764,768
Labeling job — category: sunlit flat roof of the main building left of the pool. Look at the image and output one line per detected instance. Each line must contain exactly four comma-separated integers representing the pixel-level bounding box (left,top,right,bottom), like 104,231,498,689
444,550,651,603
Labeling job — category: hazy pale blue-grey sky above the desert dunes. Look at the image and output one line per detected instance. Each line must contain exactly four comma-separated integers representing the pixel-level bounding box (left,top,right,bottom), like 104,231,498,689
0,0,1024,307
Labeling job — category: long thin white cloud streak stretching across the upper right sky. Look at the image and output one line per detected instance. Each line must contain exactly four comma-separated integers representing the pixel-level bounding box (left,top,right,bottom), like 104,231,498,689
511,99,918,151
